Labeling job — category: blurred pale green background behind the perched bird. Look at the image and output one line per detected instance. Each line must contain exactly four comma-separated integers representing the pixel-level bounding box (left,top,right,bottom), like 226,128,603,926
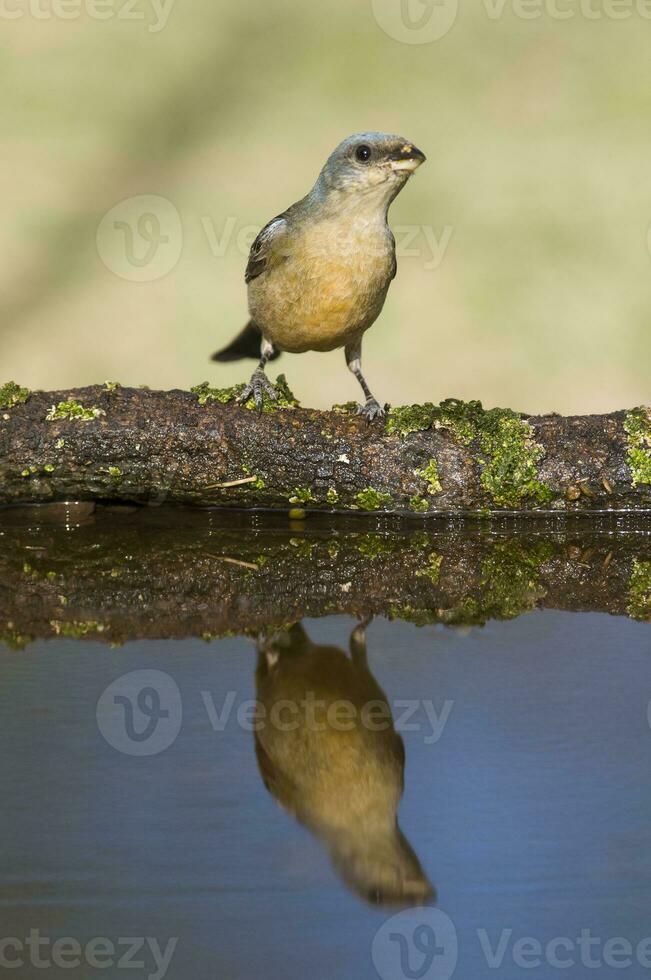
0,0,651,413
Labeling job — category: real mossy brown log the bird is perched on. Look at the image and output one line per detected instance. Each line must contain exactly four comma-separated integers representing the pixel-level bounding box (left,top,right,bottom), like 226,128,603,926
0,378,651,515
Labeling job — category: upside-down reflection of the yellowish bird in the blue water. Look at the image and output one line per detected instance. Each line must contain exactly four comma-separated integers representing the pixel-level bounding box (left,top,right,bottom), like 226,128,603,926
255,623,434,906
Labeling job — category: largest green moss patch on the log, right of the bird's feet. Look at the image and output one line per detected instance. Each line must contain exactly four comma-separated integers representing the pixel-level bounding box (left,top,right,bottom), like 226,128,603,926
387,398,552,509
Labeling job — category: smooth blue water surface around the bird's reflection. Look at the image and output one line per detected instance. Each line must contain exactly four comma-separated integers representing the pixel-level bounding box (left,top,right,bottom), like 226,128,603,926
0,611,651,980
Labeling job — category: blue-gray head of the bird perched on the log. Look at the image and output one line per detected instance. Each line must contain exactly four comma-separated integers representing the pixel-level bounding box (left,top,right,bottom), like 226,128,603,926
315,133,425,205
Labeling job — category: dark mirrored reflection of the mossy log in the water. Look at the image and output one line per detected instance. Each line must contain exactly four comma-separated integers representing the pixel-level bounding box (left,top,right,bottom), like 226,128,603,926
0,504,651,647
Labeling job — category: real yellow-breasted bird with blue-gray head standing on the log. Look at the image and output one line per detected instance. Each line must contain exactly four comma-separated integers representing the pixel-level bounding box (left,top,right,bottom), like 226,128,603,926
213,132,426,422
